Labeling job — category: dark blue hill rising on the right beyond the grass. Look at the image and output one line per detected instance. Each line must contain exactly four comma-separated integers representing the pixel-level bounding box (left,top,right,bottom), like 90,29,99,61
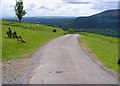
71,10,120,36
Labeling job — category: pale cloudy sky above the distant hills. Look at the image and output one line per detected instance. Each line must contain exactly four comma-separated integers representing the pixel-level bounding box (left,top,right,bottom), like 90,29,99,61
0,0,119,17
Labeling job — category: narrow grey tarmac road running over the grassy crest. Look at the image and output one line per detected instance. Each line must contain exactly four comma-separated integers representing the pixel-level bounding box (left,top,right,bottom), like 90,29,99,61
30,34,118,84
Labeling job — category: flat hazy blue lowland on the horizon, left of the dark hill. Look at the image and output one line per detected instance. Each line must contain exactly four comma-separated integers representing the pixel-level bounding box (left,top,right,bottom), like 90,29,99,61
4,16,76,30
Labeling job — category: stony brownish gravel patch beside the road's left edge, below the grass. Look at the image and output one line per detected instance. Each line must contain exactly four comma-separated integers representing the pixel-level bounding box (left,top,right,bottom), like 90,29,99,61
2,47,44,84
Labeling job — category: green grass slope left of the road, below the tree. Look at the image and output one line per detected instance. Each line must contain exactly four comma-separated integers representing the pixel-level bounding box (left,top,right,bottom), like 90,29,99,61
2,21,63,61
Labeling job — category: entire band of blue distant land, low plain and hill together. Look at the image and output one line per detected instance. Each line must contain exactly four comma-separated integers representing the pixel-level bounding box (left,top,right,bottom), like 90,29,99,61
2,9,120,36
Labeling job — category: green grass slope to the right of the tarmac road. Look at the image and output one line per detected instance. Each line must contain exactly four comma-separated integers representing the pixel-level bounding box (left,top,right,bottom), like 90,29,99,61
80,32,118,72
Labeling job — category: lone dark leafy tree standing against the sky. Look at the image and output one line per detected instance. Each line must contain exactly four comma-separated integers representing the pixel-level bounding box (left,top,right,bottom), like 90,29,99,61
14,0,26,23
